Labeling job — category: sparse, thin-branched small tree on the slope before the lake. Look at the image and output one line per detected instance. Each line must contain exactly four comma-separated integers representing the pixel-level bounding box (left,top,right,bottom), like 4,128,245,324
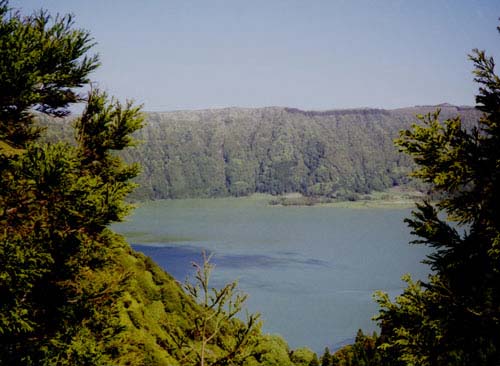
177,251,260,366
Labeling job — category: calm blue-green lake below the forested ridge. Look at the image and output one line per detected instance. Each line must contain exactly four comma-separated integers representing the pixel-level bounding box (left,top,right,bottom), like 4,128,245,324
113,197,428,353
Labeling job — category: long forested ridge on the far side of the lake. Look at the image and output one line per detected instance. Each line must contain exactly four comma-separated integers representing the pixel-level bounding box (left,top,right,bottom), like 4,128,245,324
42,104,479,199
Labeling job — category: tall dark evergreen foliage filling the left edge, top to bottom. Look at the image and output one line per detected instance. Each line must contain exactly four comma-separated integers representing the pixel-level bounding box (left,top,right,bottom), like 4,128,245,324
0,1,142,365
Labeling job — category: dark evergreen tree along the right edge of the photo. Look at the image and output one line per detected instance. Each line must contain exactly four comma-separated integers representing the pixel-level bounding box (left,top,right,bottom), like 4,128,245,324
377,27,500,365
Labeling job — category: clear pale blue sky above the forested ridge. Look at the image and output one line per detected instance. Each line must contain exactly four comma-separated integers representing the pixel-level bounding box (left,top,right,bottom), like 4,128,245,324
10,0,500,111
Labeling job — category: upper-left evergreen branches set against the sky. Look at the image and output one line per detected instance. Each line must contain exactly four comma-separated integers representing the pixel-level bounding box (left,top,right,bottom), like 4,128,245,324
0,0,99,147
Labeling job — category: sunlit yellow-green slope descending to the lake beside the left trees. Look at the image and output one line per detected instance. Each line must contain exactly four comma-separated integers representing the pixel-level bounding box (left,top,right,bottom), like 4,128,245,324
108,236,293,366
